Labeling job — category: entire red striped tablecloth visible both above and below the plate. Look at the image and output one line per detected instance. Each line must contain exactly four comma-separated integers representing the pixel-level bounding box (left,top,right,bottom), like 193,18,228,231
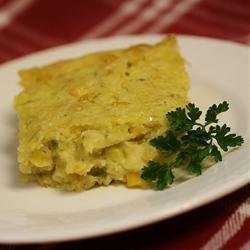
0,0,250,250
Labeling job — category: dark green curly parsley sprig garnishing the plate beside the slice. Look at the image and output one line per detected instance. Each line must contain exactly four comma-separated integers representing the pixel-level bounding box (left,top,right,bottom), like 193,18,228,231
141,101,244,190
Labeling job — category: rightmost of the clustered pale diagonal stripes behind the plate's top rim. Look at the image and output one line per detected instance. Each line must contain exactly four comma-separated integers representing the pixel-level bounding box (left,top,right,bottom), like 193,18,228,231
114,0,174,35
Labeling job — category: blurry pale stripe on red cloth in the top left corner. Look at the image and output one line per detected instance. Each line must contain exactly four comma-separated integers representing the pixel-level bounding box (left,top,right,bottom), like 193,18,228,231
0,0,34,29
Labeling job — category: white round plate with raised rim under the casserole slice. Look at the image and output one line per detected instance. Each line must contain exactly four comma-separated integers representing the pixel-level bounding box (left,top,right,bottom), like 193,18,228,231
0,35,249,243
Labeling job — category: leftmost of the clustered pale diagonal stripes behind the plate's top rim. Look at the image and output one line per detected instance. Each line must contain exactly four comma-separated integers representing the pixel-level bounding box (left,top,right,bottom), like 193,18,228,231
79,0,148,39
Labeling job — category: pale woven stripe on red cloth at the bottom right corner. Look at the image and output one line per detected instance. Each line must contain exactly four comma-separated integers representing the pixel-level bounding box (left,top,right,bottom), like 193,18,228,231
200,198,250,250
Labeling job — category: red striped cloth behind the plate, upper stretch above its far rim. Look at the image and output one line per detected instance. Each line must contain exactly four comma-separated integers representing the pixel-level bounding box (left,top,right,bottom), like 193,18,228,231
0,0,250,62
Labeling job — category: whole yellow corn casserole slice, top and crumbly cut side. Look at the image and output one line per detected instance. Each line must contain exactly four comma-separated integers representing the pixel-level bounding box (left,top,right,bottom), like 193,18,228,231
15,36,189,191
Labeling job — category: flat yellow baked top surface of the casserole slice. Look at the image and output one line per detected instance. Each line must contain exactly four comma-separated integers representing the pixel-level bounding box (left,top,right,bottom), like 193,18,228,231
15,36,189,175
